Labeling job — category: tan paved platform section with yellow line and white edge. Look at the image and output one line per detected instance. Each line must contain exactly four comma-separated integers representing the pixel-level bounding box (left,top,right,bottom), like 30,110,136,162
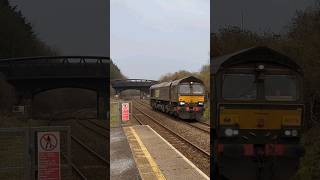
123,125,209,180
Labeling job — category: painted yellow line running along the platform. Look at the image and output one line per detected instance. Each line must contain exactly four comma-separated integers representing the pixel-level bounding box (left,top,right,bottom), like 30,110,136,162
129,127,166,180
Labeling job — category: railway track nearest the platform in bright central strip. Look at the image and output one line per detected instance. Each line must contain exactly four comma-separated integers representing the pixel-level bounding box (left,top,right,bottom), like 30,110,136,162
133,101,210,175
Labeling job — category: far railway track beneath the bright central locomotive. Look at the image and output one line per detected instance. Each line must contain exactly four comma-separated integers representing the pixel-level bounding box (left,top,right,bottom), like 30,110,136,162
134,100,210,133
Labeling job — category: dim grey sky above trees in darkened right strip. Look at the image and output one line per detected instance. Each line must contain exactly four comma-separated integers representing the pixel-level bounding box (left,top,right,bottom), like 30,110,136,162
211,0,314,33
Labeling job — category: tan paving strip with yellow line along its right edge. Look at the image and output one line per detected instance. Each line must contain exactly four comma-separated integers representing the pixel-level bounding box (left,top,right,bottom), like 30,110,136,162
123,127,166,180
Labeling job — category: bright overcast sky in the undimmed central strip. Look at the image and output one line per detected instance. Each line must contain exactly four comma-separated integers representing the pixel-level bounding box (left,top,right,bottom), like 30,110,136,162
111,0,210,79
